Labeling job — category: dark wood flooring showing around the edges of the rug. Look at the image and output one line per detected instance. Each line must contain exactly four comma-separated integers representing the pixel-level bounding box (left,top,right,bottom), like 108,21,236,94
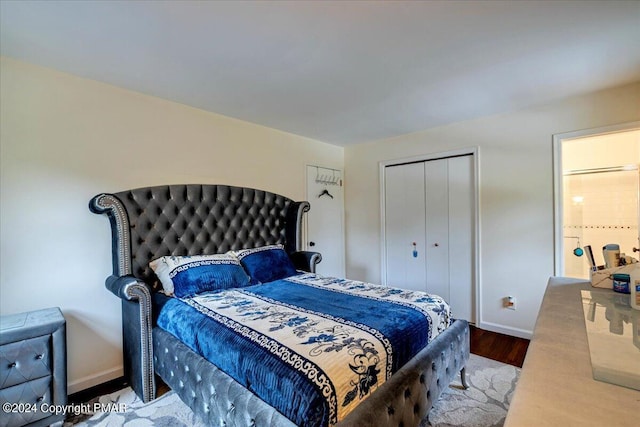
69,325,529,403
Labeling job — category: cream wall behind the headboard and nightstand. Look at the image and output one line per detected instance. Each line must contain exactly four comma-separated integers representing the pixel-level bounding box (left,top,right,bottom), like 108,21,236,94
0,58,344,393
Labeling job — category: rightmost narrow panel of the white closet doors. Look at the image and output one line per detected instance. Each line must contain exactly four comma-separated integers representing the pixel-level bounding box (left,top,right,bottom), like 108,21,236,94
448,156,475,320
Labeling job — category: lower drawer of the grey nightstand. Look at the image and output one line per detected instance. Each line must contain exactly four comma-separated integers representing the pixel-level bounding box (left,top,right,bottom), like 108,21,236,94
0,376,51,427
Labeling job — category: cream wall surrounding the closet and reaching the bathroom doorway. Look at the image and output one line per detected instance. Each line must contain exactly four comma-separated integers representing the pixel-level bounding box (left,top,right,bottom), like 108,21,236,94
345,83,640,337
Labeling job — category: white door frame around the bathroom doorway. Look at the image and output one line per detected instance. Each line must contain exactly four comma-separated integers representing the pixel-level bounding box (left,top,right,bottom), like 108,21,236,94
553,121,640,276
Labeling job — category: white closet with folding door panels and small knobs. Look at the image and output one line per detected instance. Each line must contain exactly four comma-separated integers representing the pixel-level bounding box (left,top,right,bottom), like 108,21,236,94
382,154,476,321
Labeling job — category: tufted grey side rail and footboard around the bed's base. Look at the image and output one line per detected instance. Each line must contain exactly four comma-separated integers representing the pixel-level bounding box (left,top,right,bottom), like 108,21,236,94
153,320,469,427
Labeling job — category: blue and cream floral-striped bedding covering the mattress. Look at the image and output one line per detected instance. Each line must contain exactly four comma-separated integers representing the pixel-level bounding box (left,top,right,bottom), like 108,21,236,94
157,273,452,426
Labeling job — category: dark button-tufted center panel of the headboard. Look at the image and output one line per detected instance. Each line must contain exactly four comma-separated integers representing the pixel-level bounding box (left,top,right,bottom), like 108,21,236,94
122,185,291,282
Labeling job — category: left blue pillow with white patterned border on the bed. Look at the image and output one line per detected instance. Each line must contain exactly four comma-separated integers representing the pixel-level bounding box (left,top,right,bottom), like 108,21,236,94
149,254,250,298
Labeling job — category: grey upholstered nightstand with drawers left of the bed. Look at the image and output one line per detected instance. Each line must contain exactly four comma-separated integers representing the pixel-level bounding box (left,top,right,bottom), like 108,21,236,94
0,308,67,427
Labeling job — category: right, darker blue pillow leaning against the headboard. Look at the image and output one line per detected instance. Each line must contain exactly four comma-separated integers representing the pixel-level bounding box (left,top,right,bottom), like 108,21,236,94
235,245,298,284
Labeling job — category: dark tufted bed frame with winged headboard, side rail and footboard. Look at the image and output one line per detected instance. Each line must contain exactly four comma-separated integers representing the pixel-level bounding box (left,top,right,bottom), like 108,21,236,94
89,184,469,427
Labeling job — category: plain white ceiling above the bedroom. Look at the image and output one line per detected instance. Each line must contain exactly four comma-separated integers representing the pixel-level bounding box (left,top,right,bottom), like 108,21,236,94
0,0,640,146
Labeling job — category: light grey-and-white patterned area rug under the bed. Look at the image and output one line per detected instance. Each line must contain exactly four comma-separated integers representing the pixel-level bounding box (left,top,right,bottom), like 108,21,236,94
64,354,520,427
